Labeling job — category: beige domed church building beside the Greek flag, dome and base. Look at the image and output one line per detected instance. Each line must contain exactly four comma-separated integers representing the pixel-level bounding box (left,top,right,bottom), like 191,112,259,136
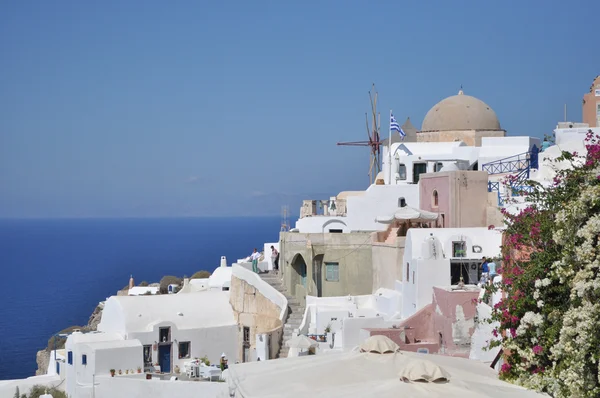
416,90,506,146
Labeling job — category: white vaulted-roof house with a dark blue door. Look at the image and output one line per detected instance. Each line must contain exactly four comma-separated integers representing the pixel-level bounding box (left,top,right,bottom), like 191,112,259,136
98,290,238,373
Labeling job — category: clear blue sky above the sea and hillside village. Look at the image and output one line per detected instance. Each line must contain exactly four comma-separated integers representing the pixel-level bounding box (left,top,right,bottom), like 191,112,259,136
0,0,600,217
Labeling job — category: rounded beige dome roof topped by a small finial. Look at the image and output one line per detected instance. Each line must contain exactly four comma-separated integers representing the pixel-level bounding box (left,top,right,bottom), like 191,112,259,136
421,90,501,131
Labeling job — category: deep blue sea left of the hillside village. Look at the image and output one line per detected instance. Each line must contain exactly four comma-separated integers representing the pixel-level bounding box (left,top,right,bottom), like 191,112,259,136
0,217,280,379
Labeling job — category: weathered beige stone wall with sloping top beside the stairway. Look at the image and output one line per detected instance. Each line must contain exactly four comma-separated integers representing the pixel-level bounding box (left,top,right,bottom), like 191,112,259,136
229,275,283,362
